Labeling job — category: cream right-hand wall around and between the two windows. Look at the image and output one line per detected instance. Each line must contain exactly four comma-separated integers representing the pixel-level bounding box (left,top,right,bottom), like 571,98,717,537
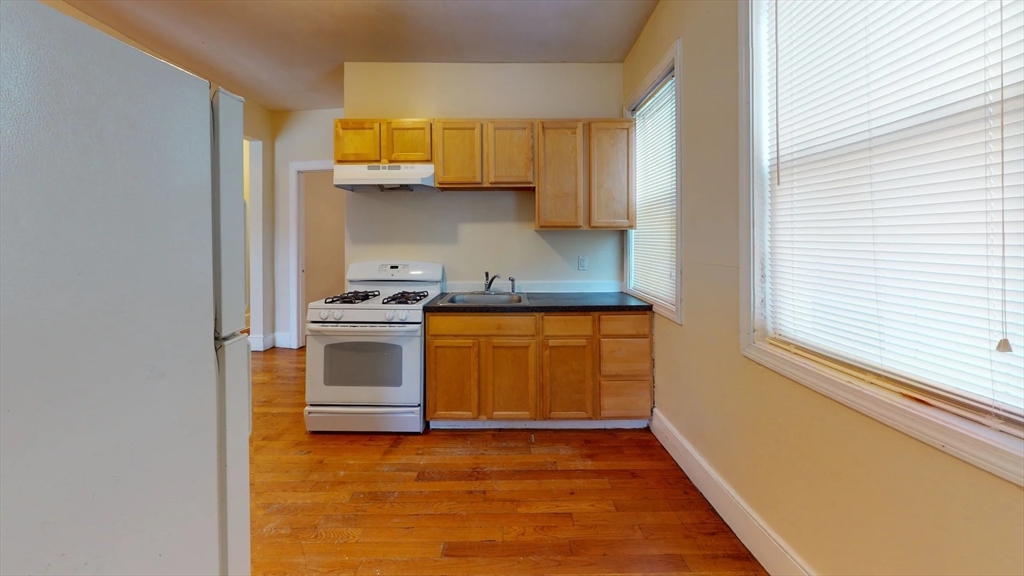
623,0,1024,574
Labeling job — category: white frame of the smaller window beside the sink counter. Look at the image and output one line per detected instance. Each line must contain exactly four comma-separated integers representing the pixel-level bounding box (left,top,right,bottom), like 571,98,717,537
623,38,683,325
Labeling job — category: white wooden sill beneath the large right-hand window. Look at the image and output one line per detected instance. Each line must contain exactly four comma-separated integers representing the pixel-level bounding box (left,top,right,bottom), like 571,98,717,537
742,342,1024,486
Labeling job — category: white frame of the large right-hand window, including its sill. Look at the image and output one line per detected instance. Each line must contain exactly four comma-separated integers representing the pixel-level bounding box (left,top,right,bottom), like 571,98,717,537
737,0,1024,486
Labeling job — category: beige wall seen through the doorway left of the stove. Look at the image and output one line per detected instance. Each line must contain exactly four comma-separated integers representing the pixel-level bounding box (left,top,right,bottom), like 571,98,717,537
302,172,346,302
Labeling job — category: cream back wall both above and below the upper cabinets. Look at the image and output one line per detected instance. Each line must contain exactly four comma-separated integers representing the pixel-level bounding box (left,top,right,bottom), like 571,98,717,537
345,63,623,290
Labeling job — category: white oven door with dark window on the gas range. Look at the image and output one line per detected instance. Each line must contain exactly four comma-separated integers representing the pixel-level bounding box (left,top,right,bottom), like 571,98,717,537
306,324,423,406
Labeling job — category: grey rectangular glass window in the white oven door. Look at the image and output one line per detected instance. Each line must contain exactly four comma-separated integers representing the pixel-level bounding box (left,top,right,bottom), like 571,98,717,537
324,342,401,387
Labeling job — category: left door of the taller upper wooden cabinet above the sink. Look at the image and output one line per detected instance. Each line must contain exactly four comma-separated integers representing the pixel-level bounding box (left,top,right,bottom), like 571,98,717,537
535,122,586,229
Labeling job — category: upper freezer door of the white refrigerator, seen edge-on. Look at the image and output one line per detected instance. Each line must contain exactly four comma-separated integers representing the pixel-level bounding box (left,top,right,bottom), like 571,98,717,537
213,89,247,337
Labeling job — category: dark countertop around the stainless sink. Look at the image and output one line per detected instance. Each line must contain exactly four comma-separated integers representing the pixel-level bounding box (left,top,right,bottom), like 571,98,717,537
423,292,653,314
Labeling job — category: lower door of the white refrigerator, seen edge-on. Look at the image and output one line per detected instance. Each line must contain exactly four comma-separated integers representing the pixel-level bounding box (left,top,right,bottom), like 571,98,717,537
217,334,252,574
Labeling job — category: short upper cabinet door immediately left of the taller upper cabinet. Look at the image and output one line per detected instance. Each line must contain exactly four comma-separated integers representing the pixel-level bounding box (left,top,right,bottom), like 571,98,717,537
483,120,534,186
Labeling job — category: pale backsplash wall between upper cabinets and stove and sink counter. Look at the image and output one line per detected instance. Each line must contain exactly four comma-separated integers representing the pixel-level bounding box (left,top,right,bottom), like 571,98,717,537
345,192,624,291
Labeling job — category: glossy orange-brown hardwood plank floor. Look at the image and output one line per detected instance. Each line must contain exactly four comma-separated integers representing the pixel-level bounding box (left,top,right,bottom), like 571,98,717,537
251,348,766,575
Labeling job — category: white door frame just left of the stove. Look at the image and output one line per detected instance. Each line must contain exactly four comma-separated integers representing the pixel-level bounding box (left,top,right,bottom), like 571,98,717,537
276,160,334,348
